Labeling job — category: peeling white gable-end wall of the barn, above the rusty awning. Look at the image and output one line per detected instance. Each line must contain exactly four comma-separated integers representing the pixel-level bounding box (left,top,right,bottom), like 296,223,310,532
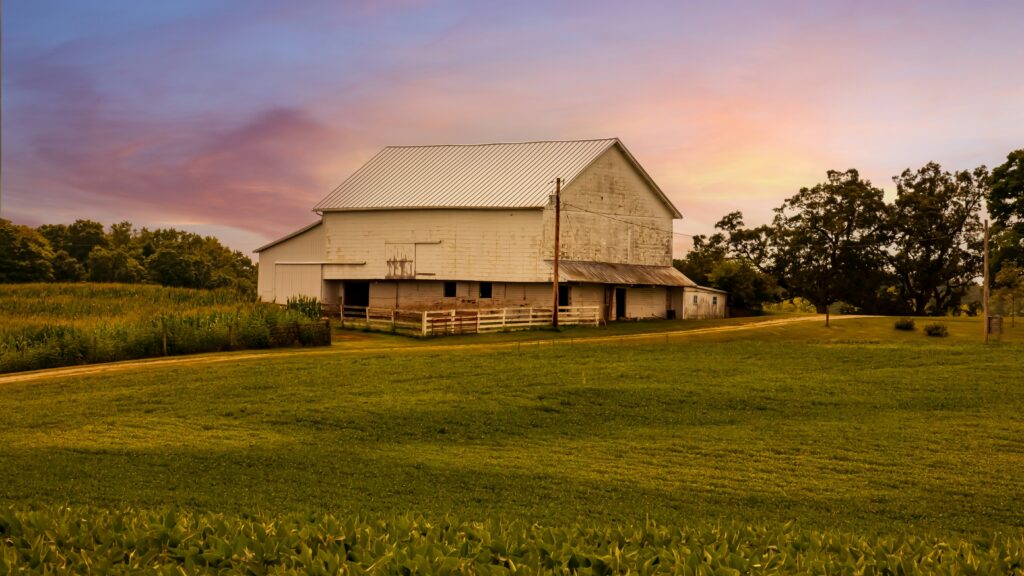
543,147,673,266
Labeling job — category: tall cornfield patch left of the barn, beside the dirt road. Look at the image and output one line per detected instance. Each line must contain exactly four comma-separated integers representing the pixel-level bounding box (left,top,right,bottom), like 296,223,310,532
0,284,330,373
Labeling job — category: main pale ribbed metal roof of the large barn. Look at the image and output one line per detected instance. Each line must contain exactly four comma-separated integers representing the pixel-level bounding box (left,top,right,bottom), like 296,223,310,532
313,138,682,218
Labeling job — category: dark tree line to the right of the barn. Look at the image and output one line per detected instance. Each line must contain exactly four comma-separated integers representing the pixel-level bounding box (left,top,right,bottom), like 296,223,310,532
675,150,1024,316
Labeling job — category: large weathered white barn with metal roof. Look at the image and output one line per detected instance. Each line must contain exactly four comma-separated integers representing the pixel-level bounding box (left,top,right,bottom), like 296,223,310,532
256,138,726,321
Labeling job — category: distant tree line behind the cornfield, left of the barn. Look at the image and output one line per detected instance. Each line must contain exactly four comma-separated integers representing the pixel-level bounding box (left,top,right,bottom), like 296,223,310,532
0,219,256,296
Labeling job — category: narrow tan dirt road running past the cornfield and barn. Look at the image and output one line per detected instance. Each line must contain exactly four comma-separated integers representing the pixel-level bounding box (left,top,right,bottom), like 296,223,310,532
0,316,864,385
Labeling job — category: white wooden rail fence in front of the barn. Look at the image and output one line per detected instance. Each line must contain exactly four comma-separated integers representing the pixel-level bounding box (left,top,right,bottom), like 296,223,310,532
341,306,601,336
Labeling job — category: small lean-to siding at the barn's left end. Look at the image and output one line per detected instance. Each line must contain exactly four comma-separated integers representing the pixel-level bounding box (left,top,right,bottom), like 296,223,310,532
256,225,324,303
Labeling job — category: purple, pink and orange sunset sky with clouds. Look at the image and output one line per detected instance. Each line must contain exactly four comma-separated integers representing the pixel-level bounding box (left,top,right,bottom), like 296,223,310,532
0,0,1024,255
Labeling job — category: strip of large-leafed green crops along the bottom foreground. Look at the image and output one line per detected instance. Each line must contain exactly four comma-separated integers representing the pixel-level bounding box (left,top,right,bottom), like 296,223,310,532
0,507,1024,575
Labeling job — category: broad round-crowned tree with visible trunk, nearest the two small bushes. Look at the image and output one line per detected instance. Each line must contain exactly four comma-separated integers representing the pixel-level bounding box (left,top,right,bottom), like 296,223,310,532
772,169,886,326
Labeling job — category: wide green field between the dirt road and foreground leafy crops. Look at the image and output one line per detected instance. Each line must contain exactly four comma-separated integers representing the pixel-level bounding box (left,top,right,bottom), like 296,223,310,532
0,319,1024,533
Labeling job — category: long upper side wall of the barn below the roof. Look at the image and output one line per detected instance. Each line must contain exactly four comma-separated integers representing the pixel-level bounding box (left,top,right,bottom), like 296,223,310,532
324,209,551,282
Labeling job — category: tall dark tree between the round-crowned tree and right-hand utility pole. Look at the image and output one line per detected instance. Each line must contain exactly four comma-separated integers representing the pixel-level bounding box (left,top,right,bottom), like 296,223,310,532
889,162,988,315
